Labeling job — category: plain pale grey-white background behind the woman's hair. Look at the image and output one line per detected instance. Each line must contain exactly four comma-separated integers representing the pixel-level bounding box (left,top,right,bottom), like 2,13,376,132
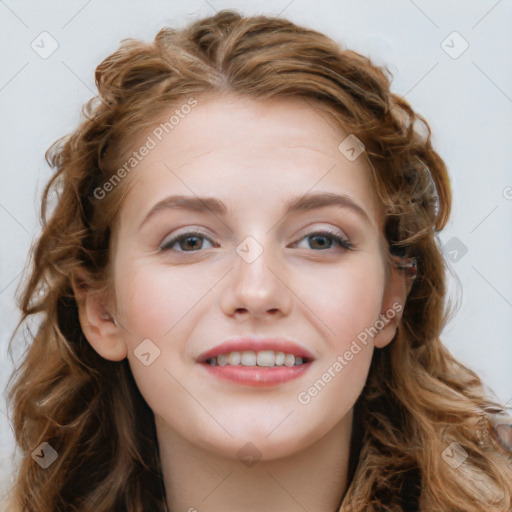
0,0,512,504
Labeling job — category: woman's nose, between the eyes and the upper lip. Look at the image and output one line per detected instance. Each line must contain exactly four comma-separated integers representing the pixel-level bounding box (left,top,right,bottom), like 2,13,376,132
221,238,293,319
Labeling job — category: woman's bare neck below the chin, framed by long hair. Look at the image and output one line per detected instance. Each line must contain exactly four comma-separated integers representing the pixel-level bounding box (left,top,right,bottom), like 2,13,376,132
155,412,352,512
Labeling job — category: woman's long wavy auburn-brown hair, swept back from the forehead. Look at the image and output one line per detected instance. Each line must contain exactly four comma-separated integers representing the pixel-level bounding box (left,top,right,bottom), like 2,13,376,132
8,11,512,512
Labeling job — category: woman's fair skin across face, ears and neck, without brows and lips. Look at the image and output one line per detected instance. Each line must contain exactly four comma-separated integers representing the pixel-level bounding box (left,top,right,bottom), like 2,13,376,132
76,95,406,512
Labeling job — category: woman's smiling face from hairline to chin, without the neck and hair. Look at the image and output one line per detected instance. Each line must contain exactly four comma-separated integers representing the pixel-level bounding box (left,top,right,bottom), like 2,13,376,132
94,96,398,459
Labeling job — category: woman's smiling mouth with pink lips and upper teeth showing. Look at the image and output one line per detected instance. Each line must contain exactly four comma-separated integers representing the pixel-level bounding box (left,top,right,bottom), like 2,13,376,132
197,338,314,386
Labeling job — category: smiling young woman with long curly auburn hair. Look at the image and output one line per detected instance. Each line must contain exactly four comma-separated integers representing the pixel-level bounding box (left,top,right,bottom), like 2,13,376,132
5,11,512,512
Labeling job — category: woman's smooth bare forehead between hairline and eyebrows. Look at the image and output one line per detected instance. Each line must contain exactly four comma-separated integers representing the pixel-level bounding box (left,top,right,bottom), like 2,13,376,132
115,95,379,230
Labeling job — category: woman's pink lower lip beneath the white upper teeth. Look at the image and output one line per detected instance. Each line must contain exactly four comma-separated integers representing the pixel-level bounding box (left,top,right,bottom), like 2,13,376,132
201,363,311,387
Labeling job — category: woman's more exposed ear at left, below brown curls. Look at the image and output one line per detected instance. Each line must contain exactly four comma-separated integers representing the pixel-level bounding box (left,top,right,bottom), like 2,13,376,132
72,272,127,361
